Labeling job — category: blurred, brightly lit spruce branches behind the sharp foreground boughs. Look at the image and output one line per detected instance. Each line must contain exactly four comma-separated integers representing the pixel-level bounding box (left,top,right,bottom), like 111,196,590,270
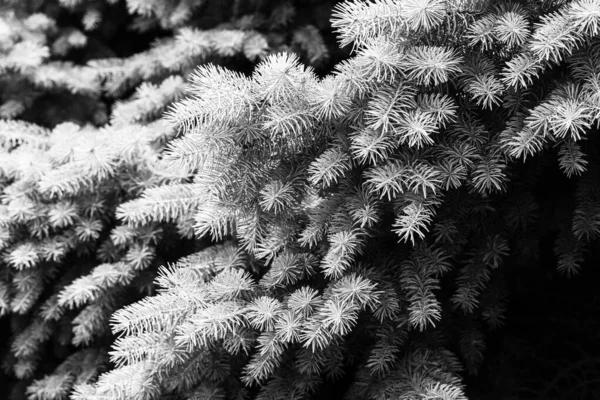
0,0,338,400
